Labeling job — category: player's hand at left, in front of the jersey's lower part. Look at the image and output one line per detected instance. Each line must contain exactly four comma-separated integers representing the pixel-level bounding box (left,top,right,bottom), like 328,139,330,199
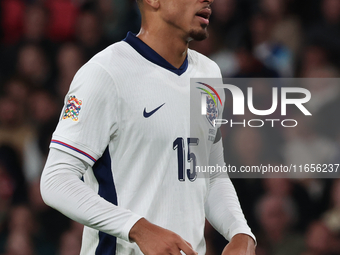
129,218,197,255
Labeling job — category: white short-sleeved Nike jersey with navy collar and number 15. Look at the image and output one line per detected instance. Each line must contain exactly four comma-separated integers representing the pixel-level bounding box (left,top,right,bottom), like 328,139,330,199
51,33,221,255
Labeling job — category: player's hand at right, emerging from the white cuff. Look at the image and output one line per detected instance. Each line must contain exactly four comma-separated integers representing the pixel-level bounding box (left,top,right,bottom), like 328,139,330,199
222,234,255,255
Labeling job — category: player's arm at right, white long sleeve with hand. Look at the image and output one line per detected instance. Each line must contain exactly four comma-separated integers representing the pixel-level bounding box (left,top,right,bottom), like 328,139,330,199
205,137,256,255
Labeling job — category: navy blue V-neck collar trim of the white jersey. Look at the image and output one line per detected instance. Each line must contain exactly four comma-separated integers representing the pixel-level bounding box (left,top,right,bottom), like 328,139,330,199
123,32,188,76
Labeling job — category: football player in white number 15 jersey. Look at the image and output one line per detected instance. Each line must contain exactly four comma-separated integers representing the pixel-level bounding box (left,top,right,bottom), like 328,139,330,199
41,0,255,255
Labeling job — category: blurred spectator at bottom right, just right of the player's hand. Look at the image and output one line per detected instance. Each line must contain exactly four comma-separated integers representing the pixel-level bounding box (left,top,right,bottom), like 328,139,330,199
257,195,303,255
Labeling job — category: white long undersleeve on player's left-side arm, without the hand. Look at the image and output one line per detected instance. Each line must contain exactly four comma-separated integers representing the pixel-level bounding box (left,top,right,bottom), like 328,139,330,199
40,148,142,241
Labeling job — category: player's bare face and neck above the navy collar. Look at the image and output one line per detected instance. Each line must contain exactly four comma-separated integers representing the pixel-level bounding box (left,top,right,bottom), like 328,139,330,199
137,0,213,68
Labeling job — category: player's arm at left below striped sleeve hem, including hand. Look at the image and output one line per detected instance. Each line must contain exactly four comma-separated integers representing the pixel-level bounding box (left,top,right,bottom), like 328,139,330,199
41,148,197,255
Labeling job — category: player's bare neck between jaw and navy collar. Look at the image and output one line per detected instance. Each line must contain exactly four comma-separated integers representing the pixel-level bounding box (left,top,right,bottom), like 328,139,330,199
137,27,188,68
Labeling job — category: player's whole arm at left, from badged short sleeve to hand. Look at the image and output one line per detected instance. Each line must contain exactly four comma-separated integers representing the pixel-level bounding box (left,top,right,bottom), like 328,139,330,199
40,63,196,255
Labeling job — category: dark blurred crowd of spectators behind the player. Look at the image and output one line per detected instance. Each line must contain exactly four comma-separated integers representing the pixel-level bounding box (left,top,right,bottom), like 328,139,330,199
0,0,340,255
